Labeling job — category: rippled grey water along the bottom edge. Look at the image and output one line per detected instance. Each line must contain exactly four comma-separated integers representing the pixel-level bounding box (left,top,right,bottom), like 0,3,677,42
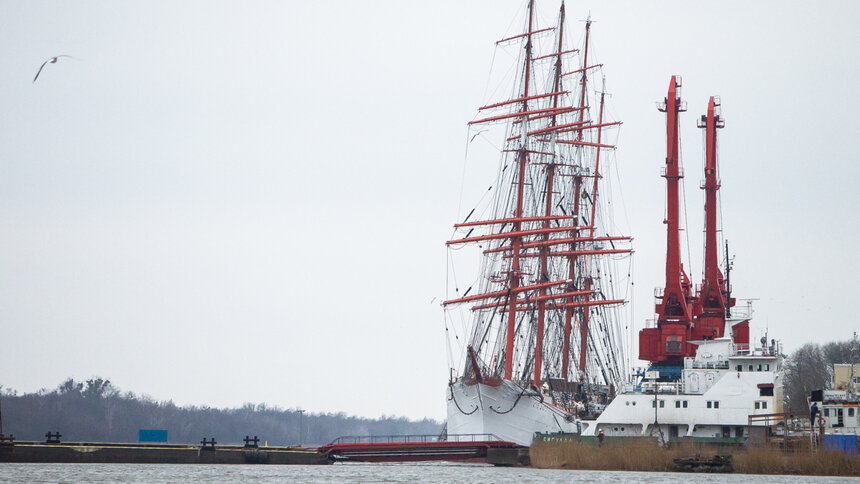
0,463,857,484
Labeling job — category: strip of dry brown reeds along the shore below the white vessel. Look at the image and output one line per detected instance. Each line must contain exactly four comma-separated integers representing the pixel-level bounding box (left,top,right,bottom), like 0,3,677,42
530,438,860,476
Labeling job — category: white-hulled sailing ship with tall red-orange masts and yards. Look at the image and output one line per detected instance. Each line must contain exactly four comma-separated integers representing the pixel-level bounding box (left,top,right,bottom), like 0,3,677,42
444,0,632,445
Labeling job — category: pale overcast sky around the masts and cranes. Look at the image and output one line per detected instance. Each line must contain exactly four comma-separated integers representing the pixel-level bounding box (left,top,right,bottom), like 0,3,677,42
0,0,860,418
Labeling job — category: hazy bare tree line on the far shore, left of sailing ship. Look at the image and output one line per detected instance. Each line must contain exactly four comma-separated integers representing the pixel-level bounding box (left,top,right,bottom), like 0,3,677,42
0,378,442,445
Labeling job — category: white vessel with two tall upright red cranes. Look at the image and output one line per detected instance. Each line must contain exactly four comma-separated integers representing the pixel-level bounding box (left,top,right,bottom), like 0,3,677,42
582,76,783,440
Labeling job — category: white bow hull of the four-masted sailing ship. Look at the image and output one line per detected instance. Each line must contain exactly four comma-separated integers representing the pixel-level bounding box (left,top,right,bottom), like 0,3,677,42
447,380,579,446
